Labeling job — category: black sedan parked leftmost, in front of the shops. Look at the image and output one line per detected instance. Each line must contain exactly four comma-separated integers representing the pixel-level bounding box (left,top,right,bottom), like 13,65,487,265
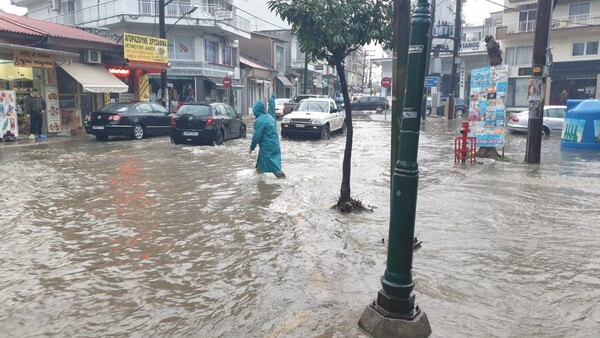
85,102,172,141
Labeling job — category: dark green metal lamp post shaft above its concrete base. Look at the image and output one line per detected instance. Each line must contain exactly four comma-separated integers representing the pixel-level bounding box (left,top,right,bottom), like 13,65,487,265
376,0,431,320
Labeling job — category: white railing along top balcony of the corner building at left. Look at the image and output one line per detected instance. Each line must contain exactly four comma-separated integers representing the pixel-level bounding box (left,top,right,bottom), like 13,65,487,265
48,0,250,32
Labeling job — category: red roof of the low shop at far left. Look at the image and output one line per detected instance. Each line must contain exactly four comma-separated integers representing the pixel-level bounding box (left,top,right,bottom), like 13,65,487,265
0,12,119,45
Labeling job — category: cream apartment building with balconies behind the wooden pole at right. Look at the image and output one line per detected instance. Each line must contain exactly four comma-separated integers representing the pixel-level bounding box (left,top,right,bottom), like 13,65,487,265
497,0,600,108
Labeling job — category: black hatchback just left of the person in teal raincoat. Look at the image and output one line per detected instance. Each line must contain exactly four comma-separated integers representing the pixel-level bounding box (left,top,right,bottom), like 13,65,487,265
171,103,246,145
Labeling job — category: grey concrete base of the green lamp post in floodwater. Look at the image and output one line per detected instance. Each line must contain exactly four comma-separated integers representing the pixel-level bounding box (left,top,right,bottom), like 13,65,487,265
358,302,431,338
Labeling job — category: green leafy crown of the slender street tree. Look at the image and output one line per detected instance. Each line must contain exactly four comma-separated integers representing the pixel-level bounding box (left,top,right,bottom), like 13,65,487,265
268,0,393,65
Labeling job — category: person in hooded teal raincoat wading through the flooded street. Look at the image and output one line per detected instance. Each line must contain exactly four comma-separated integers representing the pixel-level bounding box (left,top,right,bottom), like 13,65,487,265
250,100,285,178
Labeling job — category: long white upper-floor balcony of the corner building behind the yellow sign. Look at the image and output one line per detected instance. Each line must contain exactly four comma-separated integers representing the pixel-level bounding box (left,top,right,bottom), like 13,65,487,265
47,0,250,39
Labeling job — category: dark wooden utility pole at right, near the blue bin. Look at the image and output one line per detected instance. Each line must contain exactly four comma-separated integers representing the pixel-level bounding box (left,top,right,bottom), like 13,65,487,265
525,0,556,164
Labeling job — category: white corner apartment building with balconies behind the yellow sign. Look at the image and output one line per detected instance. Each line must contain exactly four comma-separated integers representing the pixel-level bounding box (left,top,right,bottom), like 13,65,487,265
11,0,250,109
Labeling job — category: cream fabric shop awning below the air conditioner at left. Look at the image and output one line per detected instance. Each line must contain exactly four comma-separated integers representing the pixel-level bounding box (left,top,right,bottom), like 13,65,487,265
60,63,129,93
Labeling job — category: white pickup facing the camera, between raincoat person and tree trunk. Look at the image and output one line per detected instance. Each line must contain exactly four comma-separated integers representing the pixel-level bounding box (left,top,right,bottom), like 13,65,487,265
281,98,346,140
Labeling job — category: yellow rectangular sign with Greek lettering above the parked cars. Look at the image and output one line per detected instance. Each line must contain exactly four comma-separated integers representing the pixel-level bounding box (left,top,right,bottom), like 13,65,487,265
123,33,169,63
